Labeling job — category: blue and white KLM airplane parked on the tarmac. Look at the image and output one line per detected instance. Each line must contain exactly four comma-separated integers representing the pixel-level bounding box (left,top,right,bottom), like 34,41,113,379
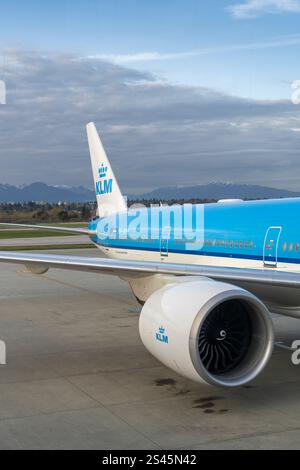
0,123,300,388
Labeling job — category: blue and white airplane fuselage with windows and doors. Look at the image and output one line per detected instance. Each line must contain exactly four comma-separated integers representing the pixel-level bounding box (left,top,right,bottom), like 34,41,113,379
89,198,300,272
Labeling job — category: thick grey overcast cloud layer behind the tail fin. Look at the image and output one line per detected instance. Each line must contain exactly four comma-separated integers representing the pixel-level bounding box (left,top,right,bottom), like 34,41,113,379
0,51,300,193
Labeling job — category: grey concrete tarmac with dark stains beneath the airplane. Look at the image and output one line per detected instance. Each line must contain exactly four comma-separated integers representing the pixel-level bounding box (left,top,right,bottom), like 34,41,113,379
0,249,300,449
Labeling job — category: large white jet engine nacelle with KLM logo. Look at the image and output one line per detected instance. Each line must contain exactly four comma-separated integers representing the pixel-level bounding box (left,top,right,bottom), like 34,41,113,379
139,278,274,387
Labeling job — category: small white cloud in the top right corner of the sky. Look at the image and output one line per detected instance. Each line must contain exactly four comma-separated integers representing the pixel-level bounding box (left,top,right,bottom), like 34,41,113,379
229,0,300,19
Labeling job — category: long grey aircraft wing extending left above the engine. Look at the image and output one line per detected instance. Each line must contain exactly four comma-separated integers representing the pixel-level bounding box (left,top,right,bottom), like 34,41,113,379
0,252,300,288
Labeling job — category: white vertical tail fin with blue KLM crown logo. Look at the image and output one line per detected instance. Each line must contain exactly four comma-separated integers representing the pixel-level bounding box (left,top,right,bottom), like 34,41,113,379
87,122,127,217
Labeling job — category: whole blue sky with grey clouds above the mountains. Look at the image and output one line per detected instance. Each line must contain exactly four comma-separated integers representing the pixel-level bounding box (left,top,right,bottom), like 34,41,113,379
0,0,300,194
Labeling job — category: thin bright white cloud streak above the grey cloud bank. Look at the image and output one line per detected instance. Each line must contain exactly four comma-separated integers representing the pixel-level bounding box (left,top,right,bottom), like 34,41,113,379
88,34,300,65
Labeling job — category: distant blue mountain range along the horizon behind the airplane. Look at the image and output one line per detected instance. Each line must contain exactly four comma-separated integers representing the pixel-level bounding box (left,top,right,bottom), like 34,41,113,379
0,182,300,203
